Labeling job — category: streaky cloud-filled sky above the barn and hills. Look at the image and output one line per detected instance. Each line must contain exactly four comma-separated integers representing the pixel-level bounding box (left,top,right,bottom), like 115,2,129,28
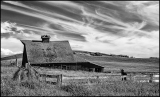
1,1,159,57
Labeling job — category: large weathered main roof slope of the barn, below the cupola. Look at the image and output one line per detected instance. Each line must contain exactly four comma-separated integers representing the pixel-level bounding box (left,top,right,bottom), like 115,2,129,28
21,40,75,64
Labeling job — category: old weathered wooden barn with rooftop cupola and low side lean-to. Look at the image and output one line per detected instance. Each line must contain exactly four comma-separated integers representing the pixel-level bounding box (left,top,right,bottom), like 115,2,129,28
21,35,104,72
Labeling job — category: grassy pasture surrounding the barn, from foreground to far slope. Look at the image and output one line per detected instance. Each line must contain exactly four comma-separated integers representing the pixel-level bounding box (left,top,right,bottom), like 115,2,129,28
1,55,159,96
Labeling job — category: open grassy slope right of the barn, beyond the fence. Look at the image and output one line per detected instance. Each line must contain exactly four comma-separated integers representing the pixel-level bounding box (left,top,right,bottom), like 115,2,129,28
77,55,159,72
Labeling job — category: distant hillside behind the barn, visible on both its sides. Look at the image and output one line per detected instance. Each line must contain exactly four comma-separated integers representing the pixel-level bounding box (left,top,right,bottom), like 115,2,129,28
1,51,159,72
